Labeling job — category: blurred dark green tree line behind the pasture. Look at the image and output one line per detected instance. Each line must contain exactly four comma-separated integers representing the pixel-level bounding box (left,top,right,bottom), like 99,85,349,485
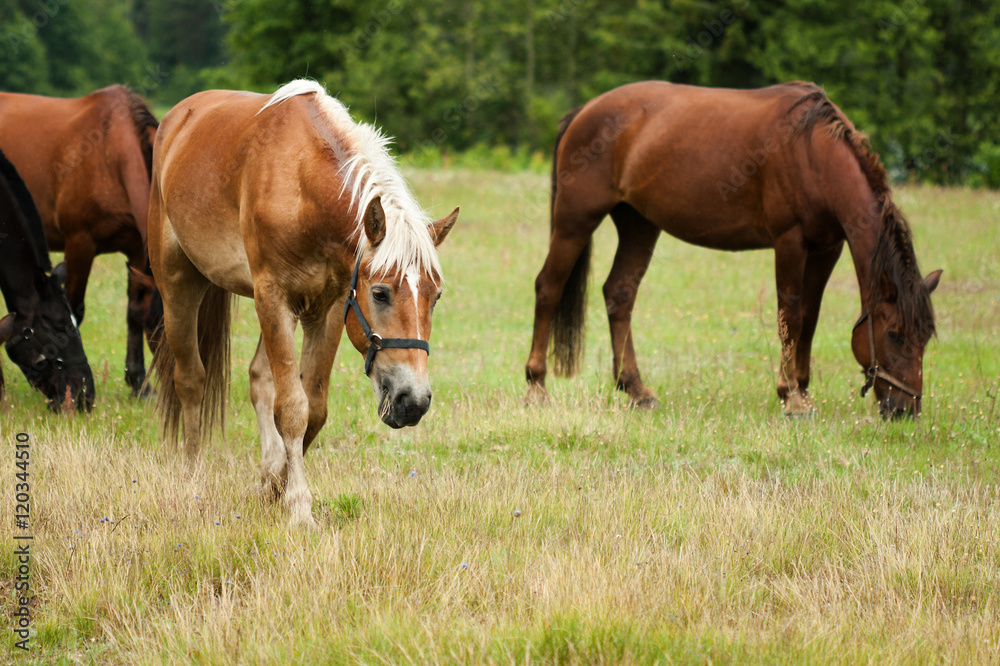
0,0,1000,187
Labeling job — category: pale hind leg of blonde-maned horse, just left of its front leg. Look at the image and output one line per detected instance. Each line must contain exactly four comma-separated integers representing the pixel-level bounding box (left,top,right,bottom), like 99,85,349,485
250,336,288,501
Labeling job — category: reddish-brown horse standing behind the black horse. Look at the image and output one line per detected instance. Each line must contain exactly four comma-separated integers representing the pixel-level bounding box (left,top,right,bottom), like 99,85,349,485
0,86,160,394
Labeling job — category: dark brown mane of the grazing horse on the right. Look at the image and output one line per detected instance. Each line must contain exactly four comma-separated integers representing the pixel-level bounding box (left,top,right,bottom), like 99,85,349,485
786,84,935,340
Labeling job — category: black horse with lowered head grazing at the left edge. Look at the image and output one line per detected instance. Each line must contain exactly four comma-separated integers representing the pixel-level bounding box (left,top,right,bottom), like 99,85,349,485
0,151,94,411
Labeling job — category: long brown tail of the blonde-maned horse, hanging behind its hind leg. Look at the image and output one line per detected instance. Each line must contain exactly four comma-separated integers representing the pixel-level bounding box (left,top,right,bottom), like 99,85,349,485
153,285,234,442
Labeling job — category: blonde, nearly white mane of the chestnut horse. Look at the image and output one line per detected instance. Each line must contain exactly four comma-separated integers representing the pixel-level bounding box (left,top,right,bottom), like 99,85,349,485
257,79,441,276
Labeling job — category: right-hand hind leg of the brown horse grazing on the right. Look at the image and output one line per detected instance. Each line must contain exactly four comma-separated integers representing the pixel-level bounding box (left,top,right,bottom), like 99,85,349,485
604,204,660,409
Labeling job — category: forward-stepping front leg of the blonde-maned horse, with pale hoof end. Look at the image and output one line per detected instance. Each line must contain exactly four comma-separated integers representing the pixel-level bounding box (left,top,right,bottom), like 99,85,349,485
254,280,316,527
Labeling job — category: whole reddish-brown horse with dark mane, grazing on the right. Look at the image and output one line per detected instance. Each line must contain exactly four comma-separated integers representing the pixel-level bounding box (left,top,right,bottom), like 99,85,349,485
525,82,941,417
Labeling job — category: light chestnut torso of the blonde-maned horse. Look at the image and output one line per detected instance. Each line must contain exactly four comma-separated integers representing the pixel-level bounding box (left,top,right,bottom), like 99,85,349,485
150,90,347,296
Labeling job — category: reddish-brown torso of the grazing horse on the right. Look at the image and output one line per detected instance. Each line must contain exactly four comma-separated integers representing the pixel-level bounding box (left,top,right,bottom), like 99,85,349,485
557,81,852,250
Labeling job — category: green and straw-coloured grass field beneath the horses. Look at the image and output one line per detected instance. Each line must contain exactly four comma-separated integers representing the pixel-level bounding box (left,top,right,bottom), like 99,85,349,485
0,170,1000,664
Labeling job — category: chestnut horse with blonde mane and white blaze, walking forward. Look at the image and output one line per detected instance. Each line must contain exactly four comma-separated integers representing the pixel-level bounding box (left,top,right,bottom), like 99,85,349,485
149,80,458,524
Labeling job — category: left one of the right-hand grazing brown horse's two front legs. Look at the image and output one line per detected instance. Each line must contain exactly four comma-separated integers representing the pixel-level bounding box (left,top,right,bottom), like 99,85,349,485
774,227,812,416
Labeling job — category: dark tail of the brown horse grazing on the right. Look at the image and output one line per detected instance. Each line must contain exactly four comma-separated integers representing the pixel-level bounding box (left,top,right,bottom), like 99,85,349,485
549,106,593,377
